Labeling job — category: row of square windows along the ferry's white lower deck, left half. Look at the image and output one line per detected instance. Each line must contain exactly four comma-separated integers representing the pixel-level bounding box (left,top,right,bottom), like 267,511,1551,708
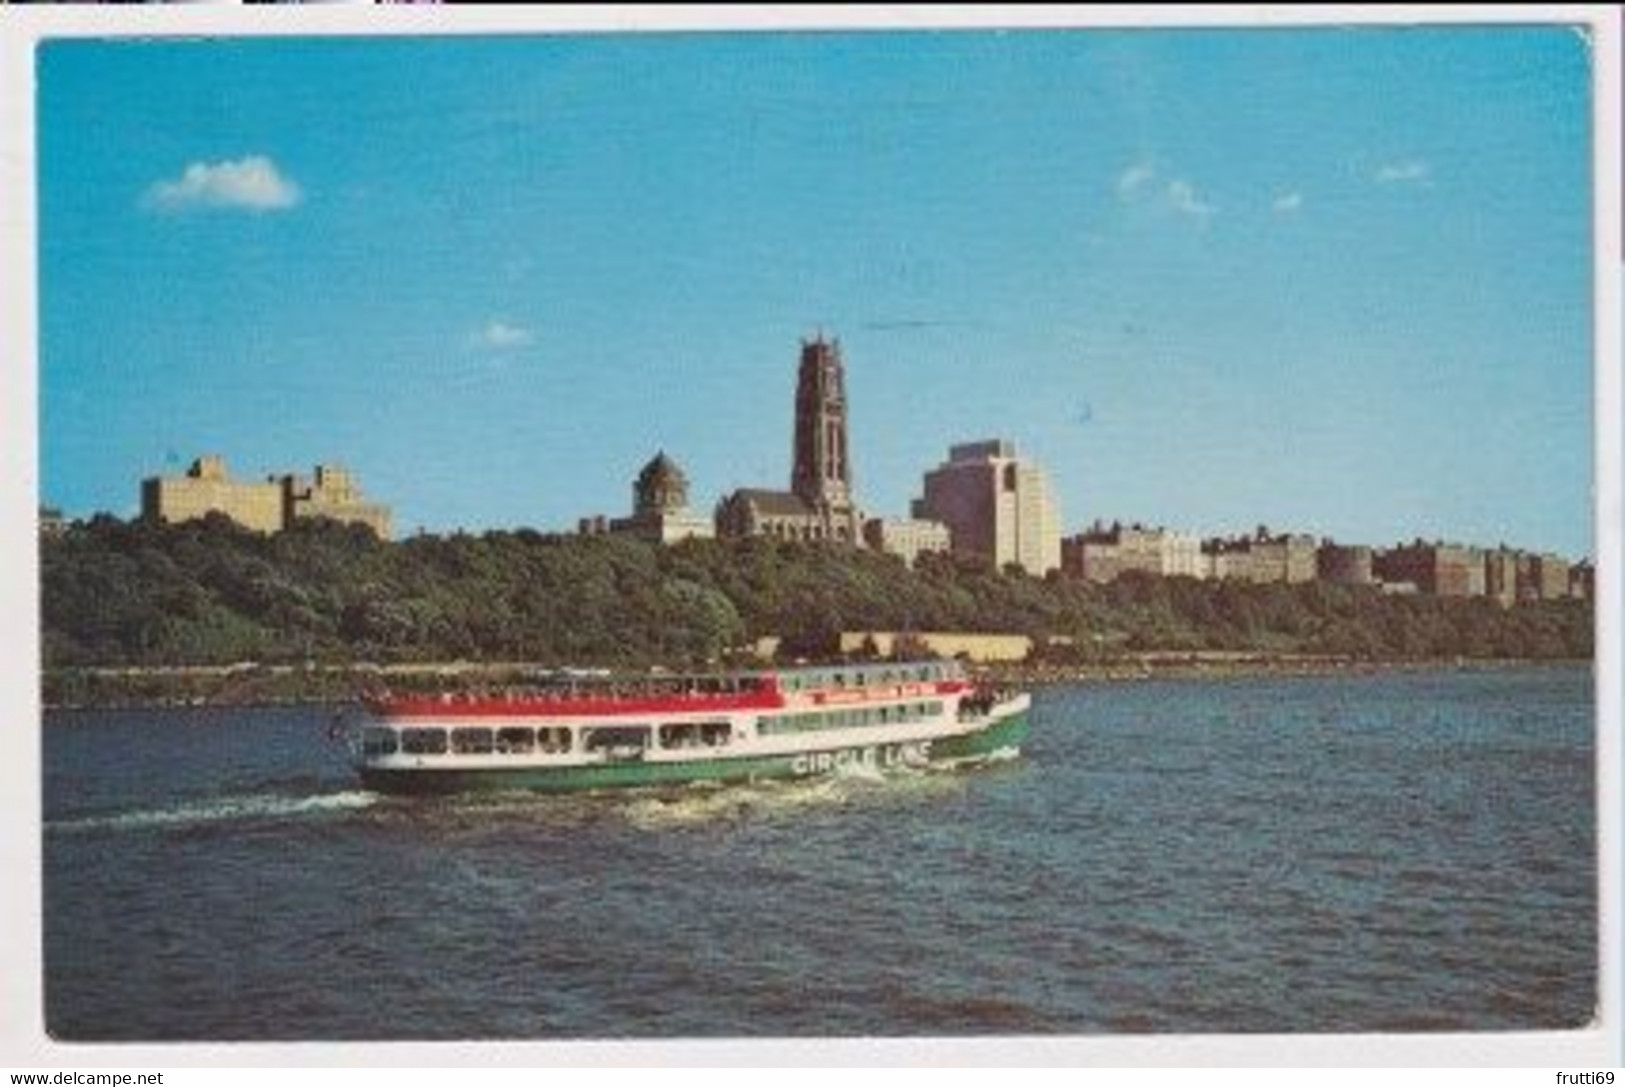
361,721,731,756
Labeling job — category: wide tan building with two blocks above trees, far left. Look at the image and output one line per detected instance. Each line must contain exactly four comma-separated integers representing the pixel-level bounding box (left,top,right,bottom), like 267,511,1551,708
141,457,390,539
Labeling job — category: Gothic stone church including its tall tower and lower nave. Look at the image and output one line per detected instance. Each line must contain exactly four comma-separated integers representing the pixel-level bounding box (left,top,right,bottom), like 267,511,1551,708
717,335,863,544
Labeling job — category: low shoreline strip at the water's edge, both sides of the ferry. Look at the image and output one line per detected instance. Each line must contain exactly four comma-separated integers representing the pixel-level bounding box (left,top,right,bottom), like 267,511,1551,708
31,652,1596,712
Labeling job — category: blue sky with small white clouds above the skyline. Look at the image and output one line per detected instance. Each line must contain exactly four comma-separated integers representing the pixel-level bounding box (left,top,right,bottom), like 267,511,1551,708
39,28,1593,556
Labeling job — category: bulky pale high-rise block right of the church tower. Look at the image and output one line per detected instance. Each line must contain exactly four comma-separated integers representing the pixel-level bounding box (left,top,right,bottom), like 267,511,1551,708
915,440,1061,575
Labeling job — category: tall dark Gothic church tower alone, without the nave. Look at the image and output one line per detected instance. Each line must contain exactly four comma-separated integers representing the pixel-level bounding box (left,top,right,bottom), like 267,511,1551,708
790,335,855,529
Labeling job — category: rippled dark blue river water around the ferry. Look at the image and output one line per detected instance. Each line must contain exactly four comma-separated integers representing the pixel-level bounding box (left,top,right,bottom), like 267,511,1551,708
44,669,1597,1040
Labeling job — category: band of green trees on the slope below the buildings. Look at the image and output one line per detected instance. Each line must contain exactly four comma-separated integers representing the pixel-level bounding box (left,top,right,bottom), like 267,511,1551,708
41,515,1593,668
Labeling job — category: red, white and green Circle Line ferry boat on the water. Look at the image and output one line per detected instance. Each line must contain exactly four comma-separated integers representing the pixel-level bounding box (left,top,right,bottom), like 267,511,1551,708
356,661,1032,793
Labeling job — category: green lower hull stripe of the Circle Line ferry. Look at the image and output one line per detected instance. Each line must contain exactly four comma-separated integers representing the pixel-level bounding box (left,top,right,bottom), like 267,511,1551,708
361,712,1027,793
